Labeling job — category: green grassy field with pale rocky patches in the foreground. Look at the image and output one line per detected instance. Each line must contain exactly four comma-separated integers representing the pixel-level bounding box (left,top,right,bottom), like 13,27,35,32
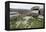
10,16,43,29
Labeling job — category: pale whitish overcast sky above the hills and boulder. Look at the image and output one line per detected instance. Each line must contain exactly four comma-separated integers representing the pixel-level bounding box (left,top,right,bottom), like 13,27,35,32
10,3,43,9
